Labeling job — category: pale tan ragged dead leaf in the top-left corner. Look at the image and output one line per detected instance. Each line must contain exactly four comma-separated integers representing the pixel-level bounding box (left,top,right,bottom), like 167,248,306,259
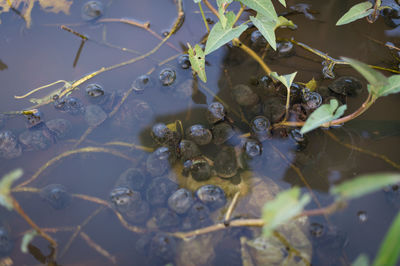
0,0,73,28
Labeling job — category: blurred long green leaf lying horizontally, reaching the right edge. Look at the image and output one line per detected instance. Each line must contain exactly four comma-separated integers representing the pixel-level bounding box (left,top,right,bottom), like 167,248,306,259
331,173,400,200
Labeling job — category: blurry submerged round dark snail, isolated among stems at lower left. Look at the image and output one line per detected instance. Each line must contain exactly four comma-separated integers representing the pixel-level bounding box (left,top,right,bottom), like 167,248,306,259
40,184,71,210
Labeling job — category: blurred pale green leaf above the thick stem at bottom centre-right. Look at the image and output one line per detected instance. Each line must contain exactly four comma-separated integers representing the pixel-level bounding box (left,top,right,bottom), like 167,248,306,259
262,187,311,237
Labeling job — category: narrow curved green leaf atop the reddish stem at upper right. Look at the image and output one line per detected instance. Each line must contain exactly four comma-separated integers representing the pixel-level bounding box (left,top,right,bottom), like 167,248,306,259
342,57,388,97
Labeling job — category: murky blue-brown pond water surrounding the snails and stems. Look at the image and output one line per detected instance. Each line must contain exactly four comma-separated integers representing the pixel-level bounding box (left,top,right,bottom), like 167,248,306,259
0,0,400,265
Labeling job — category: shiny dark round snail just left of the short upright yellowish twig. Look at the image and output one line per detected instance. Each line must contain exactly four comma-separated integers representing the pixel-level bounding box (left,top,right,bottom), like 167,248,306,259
196,185,226,210
